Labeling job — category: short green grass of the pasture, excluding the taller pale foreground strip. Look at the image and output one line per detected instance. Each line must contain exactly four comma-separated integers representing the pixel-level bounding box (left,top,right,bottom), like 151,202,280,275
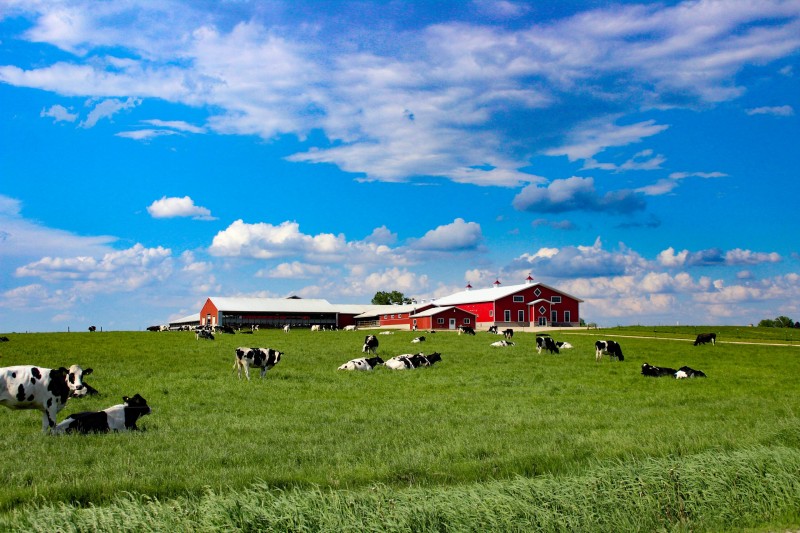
0,330,800,529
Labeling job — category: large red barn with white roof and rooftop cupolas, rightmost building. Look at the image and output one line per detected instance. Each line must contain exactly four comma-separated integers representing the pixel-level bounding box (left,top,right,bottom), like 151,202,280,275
435,276,583,327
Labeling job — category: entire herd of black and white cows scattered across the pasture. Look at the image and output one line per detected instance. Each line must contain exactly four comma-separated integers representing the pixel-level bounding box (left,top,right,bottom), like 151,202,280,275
0,327,717,434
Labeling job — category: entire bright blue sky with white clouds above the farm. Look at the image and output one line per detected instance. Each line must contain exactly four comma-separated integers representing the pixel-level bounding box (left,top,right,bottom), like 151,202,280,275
0,0,800,331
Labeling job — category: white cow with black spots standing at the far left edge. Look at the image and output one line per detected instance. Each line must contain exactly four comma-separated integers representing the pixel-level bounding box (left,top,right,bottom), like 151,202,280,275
0,365,92,432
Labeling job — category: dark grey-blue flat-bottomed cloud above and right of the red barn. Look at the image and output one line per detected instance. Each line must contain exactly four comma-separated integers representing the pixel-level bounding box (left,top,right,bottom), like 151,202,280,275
512,176,645,214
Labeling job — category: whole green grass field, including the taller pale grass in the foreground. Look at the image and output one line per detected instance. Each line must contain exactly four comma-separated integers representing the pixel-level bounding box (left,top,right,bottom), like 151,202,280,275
0,328,800,531
